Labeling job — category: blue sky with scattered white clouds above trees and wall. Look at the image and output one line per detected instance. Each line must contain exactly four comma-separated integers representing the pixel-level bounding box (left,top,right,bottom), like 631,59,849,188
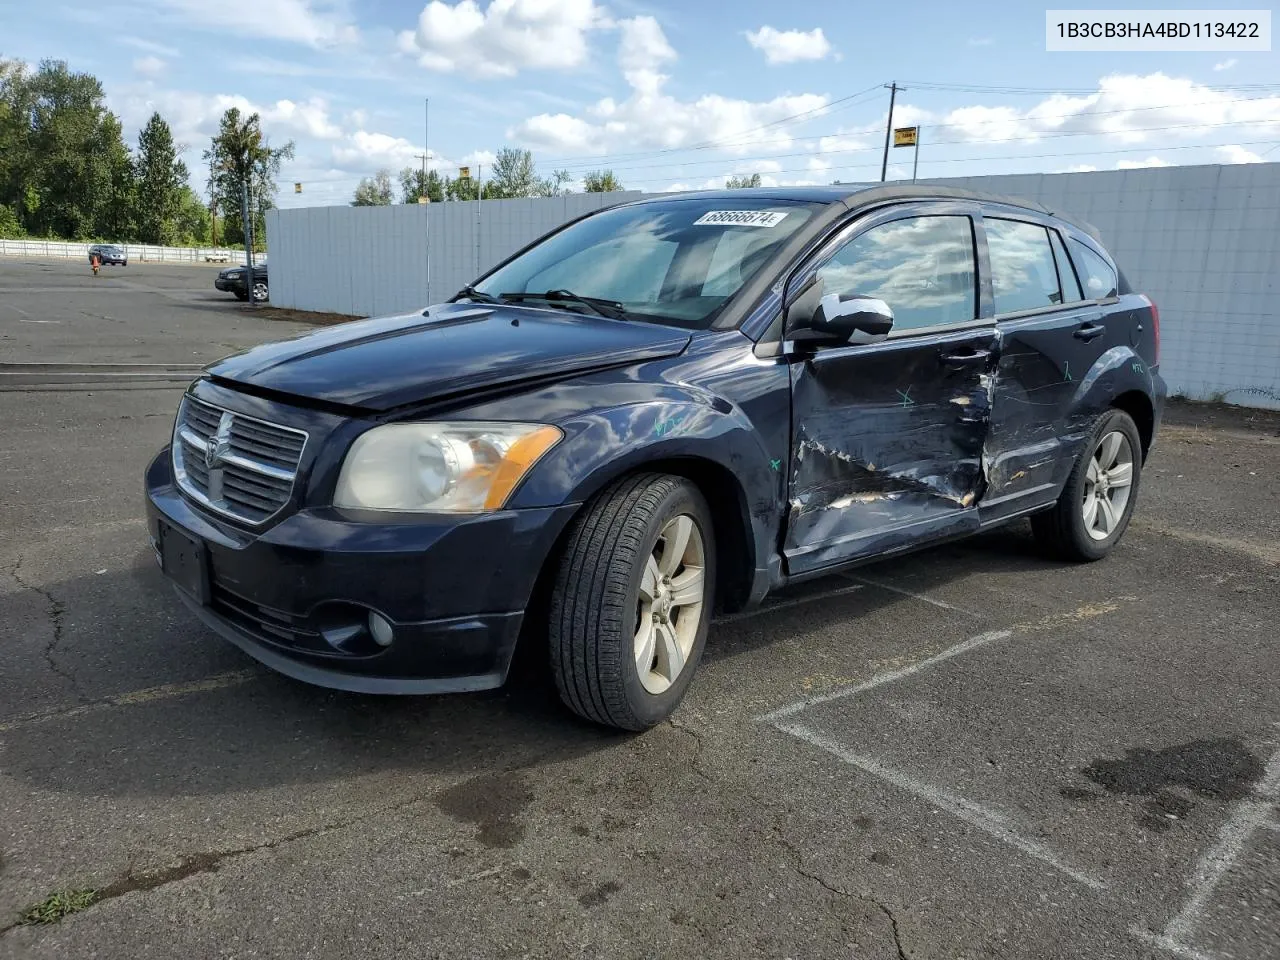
0,0,1280,206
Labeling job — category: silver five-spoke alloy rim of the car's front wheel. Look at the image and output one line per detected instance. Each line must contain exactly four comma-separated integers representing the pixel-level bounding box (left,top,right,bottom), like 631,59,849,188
635,513,707,695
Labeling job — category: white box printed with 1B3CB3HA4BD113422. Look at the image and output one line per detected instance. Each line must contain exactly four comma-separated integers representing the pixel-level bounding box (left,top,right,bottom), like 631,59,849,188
1044,10,1271,54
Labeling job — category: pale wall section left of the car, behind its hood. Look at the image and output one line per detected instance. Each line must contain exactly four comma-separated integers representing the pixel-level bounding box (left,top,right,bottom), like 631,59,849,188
266,192,643,316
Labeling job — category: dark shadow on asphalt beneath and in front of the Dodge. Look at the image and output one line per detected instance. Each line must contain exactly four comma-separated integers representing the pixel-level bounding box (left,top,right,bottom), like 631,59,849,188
0,532,1062,797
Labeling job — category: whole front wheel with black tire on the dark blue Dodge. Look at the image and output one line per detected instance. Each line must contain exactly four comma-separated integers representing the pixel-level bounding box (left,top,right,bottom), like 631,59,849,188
548,474,716,731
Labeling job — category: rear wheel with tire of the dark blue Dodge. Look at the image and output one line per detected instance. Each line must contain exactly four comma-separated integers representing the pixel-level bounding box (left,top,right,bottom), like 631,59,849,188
1032,410,1142,562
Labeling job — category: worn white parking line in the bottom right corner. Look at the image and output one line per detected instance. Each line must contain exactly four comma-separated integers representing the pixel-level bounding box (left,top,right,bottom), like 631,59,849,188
1132,750,1280,960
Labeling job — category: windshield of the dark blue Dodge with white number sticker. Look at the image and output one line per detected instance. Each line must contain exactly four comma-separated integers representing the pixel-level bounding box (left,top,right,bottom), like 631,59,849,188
473,197,817,329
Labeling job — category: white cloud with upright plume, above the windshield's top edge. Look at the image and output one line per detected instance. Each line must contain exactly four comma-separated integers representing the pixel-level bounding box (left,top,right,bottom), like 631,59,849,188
507,17,827,154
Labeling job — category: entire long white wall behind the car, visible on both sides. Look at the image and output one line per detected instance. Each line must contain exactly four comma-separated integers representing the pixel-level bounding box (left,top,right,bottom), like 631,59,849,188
266,164,1280,408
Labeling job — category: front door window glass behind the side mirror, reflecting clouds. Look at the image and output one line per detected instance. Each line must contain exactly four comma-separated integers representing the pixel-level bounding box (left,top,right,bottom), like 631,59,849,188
818,216,977,330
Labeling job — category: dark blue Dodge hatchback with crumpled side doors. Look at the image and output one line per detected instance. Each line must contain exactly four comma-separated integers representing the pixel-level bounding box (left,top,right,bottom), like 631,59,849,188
146,186,1165,730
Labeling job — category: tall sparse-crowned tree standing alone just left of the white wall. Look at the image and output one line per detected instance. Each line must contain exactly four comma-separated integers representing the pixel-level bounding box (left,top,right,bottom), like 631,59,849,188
204,106,293,248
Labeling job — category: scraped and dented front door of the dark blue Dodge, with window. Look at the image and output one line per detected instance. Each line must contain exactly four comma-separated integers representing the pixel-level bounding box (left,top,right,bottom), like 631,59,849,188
785,202,998,576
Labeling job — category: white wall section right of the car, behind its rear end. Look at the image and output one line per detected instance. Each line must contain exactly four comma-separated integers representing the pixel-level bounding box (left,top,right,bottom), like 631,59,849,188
931,164,1280,410
